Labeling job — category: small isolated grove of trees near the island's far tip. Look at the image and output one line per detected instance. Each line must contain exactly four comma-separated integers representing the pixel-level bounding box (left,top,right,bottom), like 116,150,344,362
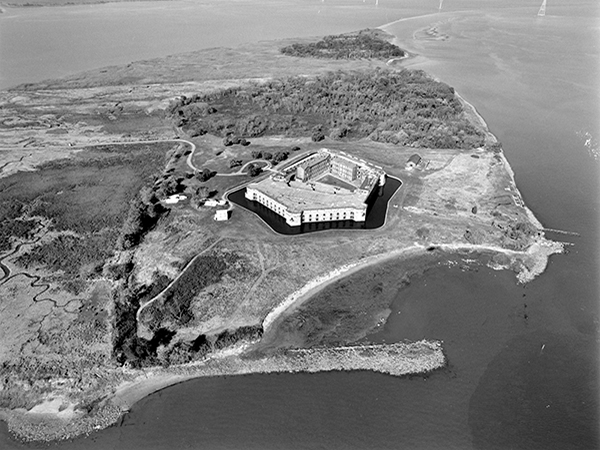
281,30,405,59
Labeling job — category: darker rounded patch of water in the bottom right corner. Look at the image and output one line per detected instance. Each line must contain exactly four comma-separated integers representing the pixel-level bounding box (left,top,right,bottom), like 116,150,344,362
469,331,600,450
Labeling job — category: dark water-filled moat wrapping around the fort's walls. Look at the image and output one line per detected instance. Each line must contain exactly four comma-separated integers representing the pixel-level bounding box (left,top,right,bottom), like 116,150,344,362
227,177,402,235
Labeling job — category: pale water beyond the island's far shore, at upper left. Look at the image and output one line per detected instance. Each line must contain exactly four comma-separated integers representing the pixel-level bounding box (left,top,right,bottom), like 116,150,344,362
0,0,418,89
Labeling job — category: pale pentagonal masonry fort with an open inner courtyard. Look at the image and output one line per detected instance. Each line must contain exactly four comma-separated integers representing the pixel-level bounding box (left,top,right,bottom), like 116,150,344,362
245,148,386,226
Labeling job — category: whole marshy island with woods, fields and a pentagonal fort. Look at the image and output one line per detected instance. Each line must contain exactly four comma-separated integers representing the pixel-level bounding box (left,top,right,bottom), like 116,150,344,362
0,30,562,441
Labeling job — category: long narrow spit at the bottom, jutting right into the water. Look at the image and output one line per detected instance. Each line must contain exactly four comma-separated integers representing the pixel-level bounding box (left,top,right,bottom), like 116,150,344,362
0,340,446,441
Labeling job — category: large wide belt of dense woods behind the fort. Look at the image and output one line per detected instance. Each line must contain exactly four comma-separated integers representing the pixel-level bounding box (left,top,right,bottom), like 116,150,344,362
169,70,484,149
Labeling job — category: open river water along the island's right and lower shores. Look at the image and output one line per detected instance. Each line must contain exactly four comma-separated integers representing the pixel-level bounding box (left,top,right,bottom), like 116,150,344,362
0,0,600,449
